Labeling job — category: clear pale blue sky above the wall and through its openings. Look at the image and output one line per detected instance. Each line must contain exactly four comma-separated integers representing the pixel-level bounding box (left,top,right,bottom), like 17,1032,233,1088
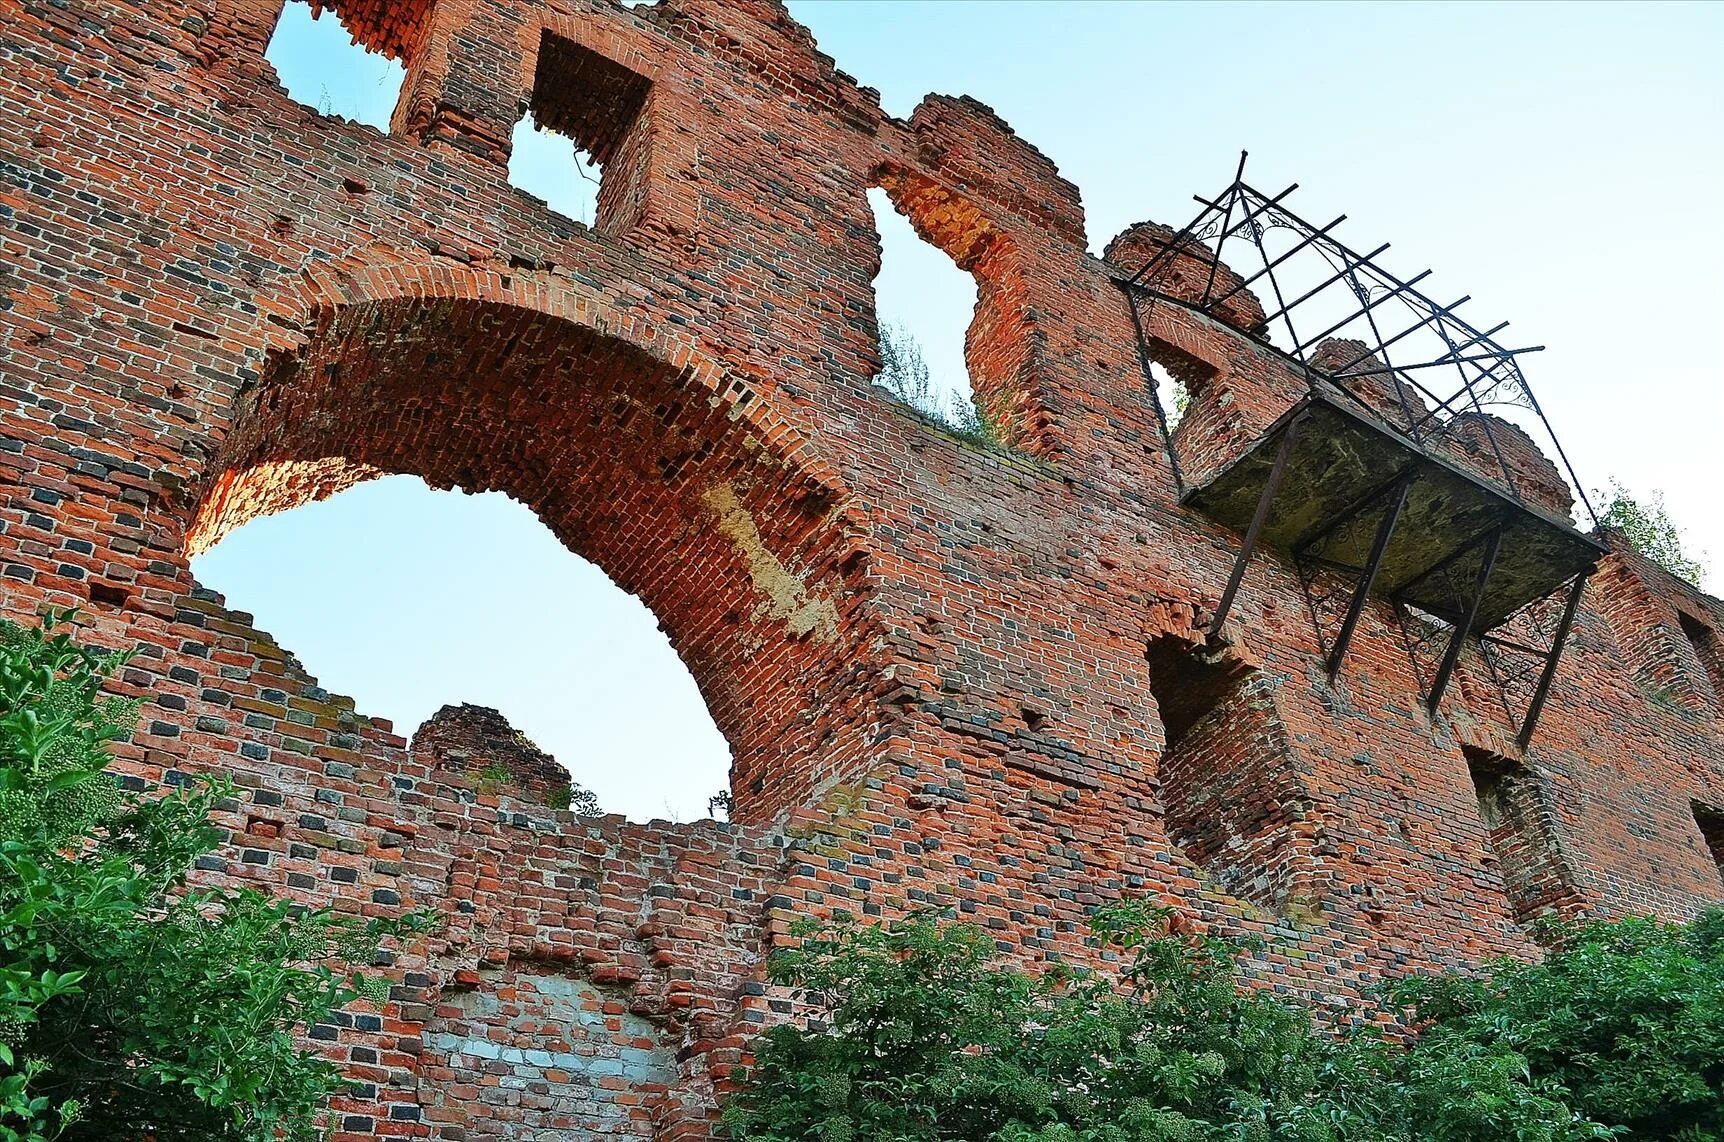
205,0,1724,818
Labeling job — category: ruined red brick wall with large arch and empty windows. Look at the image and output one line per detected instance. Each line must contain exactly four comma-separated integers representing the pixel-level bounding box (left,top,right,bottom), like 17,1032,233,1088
0,0,1724,1140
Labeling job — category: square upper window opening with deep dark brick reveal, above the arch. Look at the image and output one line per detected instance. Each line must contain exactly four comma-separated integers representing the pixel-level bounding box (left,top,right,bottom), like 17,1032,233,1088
509,31,652,233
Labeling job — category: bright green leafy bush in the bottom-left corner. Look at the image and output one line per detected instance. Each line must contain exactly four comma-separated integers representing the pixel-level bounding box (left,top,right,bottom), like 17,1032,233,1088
0,612,426,1142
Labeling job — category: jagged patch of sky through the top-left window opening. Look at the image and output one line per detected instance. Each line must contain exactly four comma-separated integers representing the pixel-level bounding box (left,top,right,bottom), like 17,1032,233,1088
264,0,407,131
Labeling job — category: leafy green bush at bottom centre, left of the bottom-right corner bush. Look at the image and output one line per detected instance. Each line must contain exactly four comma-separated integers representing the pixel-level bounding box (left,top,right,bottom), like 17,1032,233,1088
724,904,1386,1142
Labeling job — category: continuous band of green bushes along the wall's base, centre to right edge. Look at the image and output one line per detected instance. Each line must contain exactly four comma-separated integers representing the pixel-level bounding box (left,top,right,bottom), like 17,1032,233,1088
722,902,1724,1142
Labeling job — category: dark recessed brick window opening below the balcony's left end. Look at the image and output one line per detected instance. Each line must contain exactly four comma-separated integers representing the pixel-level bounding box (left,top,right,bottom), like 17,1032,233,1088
1148,638,1310,909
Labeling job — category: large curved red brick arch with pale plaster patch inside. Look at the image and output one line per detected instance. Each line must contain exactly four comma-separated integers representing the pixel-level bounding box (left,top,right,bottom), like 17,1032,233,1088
186,266,865,821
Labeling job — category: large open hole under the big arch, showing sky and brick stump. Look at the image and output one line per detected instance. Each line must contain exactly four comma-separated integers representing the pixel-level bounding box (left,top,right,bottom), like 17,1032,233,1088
193,476,729,821
